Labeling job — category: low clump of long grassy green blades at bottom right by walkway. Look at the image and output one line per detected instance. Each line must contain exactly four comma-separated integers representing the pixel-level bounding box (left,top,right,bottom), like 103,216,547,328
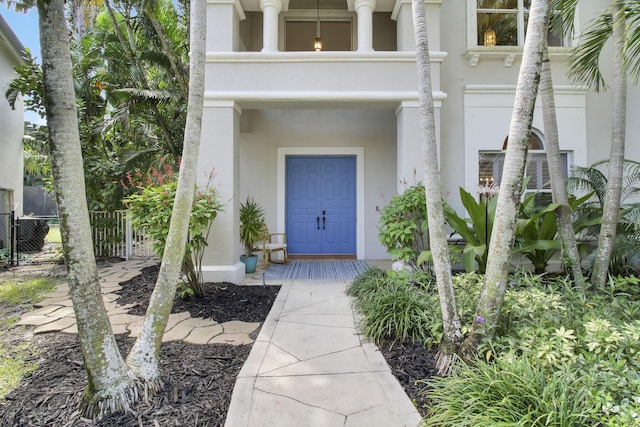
423,358,596,427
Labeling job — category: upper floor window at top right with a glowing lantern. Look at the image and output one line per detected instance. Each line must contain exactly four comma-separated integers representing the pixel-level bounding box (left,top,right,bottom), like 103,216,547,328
474,0,564,46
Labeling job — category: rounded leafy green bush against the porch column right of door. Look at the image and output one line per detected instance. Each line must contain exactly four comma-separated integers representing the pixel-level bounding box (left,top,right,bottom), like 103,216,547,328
378,184,429,269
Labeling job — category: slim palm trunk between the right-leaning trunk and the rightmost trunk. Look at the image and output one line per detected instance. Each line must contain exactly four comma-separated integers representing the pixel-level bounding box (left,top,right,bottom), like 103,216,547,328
540,45,584,283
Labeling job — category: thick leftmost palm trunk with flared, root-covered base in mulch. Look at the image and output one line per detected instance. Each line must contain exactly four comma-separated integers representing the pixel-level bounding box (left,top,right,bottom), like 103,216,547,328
38,0,138,416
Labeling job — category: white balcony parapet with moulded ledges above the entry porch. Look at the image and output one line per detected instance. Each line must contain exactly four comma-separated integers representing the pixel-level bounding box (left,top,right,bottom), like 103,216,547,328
206,52,446,108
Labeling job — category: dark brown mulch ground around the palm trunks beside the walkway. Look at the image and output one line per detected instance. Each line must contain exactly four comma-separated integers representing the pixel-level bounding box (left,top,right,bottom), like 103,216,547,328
0,267,434,427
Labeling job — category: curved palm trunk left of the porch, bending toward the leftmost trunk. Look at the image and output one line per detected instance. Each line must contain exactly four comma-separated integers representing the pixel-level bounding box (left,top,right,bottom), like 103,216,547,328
127,0,206,386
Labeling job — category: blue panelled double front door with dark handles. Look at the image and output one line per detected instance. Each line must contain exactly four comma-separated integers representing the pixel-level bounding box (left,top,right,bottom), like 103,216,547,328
285,156,356,255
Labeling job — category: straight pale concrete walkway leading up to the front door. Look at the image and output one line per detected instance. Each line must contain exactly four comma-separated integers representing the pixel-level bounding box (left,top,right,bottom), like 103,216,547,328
225,280,420,427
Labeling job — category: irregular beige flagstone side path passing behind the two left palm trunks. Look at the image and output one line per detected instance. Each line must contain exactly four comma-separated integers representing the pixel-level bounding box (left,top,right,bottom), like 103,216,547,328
17,260,260,345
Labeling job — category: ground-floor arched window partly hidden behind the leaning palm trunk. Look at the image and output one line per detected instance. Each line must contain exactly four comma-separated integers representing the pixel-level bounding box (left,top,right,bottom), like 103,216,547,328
478,128,568,192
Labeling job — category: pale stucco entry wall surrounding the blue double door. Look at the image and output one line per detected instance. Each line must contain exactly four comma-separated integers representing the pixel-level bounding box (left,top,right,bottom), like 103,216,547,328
237,109,396,259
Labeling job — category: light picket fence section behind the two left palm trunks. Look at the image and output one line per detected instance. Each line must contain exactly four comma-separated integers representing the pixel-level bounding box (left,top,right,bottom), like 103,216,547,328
89,210,155,260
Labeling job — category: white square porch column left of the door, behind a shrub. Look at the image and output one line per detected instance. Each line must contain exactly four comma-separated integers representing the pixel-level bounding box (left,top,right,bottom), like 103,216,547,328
198,100,245,283
